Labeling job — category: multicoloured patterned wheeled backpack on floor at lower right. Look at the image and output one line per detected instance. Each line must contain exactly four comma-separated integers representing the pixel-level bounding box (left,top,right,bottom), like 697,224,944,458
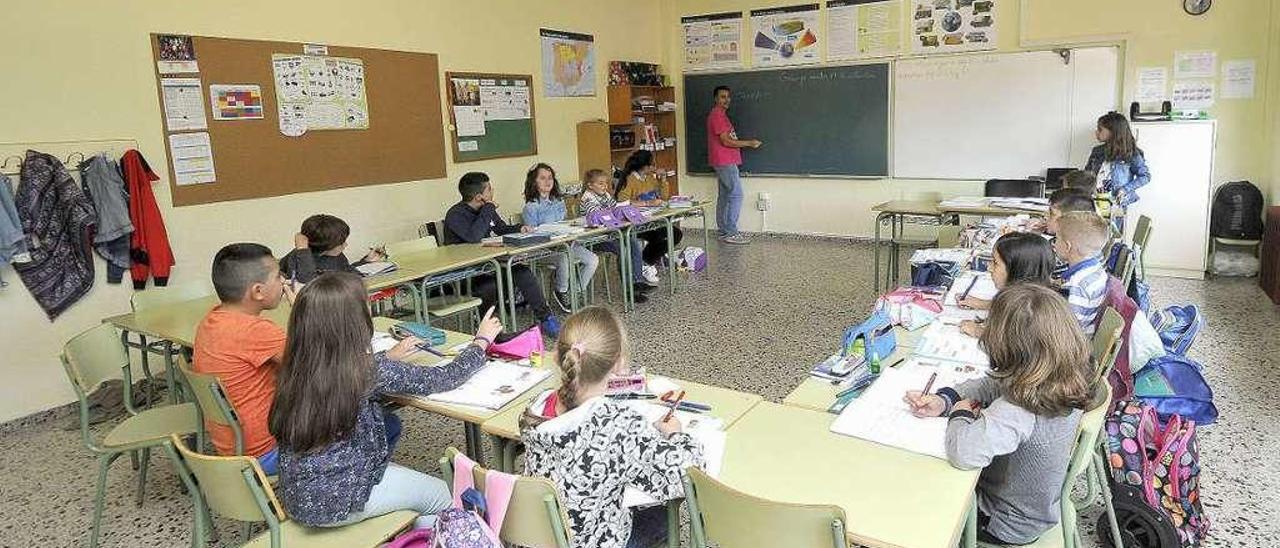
1106,401,1210,548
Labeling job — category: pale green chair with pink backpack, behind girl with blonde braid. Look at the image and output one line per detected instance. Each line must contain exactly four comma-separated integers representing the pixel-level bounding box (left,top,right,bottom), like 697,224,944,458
440,447,570,548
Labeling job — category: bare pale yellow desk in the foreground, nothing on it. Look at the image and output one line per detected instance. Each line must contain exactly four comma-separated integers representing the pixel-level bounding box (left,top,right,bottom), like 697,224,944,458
719,402,978,548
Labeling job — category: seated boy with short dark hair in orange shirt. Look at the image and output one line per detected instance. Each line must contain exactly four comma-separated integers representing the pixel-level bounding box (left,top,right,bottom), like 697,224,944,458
192,243,293,474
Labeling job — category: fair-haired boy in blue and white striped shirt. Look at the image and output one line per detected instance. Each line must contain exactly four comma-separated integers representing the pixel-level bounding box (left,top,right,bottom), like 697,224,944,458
1053,211,1108,337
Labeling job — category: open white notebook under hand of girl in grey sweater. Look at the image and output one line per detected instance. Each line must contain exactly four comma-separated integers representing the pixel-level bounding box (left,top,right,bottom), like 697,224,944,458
831,359,986,458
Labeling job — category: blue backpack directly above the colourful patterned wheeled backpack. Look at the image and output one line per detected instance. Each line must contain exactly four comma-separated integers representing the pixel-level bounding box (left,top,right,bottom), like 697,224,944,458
1134,355,1217,426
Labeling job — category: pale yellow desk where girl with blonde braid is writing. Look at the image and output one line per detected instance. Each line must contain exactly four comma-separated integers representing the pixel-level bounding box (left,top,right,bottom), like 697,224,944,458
480,373,762,472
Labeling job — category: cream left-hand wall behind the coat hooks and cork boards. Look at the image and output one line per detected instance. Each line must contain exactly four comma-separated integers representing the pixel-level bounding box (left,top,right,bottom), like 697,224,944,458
0,0,662,421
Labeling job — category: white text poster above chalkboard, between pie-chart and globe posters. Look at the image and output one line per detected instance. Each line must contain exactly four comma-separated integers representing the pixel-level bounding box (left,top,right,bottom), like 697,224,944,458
827,0,902,59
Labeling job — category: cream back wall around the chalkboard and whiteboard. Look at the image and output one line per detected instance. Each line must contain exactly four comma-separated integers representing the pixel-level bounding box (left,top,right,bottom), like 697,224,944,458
662,0,1280,237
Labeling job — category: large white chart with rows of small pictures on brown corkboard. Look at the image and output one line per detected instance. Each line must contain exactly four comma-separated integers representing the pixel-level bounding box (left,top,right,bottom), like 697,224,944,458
271,54,369,137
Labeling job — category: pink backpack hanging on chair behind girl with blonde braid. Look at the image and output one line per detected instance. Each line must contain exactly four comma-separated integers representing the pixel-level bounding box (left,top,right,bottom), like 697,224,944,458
435,453,516,548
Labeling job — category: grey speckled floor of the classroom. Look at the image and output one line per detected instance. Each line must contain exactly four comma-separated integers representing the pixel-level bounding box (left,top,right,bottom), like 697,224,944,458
0,237,1280,548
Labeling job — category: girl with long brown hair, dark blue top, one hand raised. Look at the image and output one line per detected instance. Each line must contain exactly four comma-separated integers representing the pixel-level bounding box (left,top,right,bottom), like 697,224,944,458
270,273,502,528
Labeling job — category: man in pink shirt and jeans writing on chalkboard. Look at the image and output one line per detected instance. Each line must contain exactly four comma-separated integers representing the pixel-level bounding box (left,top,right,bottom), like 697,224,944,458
707,86,760,246
